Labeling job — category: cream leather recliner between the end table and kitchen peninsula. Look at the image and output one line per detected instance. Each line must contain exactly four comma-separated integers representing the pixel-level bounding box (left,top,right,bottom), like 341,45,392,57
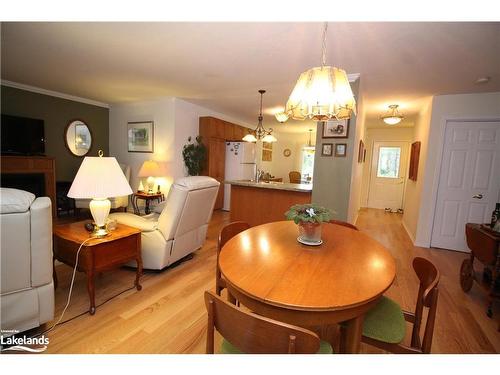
109,176,220,270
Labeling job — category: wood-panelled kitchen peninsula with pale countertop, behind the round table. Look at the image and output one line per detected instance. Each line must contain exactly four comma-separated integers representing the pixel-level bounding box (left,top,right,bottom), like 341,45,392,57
226,180,312,227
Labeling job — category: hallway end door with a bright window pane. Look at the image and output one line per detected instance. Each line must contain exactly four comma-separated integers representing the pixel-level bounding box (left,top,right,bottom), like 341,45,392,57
368,141,408,210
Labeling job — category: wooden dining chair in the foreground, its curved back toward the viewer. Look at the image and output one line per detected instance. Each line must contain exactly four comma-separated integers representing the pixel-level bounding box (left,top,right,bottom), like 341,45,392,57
205,291,333,354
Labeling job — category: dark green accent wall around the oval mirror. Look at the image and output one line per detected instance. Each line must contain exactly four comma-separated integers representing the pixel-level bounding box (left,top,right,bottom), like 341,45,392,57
1,86,109,181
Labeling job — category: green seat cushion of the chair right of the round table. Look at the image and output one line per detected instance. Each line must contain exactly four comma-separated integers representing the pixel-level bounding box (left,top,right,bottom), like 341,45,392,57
363,297,406,344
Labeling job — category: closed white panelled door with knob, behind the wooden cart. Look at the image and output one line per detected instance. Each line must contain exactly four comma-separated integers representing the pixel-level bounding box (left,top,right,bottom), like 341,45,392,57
431,122,500,252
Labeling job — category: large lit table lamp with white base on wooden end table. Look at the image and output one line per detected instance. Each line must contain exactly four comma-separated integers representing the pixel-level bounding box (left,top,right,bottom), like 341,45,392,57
68,151,132,238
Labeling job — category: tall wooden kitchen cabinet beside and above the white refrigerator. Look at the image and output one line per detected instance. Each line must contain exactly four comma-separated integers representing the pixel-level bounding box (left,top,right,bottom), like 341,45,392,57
200,116,247,209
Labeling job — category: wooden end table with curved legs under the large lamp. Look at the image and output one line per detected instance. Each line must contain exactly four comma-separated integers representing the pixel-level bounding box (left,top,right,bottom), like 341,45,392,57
53,221,142,315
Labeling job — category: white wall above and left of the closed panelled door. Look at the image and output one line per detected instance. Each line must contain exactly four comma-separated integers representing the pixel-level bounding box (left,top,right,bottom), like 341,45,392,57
415,92,500,247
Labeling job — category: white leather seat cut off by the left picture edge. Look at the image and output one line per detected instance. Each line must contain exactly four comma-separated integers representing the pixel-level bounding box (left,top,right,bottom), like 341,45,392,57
0,188,54,335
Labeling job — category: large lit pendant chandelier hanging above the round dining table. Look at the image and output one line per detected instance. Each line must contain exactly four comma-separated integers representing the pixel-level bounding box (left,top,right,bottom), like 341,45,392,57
275,22,356,122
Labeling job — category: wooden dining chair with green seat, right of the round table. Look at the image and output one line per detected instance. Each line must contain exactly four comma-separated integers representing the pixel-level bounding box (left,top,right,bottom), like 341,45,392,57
342,257,440,354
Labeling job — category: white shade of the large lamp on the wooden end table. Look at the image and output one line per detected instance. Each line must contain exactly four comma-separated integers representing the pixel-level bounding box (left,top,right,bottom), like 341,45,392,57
68,156,132,199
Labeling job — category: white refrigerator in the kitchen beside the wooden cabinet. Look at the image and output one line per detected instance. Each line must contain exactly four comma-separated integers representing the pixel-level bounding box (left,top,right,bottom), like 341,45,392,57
222,142,256,211
